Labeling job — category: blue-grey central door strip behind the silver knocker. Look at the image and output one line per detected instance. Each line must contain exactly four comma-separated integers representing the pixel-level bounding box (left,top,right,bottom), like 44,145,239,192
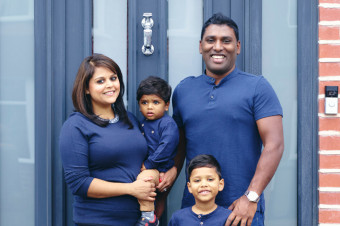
127,0,168,118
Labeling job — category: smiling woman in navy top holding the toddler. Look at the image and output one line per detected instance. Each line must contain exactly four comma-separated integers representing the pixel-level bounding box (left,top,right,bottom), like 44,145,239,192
60,54,156,226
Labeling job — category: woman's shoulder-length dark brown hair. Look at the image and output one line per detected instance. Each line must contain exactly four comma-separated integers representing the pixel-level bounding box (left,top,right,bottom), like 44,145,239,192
72,54,133,128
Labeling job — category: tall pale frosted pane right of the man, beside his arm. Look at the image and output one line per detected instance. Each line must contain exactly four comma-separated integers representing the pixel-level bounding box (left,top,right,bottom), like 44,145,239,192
262,0,297,226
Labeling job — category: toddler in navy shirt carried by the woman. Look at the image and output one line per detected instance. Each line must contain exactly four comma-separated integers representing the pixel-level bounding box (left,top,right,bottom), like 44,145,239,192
137,76,179,226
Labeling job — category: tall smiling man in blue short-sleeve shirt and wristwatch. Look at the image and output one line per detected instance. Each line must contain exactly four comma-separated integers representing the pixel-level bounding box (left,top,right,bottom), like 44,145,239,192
159,14,284,226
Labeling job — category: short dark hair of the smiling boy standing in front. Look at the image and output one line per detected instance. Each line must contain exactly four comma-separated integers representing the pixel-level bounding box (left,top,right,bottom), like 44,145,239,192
188,155,222,180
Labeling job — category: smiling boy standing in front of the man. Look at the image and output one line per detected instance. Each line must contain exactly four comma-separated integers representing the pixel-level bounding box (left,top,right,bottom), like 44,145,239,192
169,155,231,226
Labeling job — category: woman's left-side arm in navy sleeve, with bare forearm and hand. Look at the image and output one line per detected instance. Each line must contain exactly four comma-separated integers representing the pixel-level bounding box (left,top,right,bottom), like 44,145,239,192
59,117,156,201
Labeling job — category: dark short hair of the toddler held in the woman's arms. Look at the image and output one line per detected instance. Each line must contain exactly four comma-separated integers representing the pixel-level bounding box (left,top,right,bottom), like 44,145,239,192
137,76,171,103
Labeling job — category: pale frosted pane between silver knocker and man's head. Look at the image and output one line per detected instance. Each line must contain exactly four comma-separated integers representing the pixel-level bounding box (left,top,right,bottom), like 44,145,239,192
167,0,203,220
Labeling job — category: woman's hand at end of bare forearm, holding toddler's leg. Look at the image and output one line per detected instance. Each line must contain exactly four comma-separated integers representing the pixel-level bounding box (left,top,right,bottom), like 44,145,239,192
131,177,157,201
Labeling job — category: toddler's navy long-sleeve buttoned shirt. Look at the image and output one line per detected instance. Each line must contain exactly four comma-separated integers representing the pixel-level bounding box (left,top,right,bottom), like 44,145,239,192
142,114,179,172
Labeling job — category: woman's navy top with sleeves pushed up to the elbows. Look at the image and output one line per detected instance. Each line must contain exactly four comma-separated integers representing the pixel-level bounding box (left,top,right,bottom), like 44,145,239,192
60,112,147,226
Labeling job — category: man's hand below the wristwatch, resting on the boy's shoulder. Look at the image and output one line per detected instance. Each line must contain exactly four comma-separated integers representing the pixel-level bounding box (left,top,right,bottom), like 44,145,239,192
225,195,257,226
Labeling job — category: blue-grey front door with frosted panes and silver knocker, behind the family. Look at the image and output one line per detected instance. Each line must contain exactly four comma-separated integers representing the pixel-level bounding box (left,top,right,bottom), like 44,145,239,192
93,0,297,225
